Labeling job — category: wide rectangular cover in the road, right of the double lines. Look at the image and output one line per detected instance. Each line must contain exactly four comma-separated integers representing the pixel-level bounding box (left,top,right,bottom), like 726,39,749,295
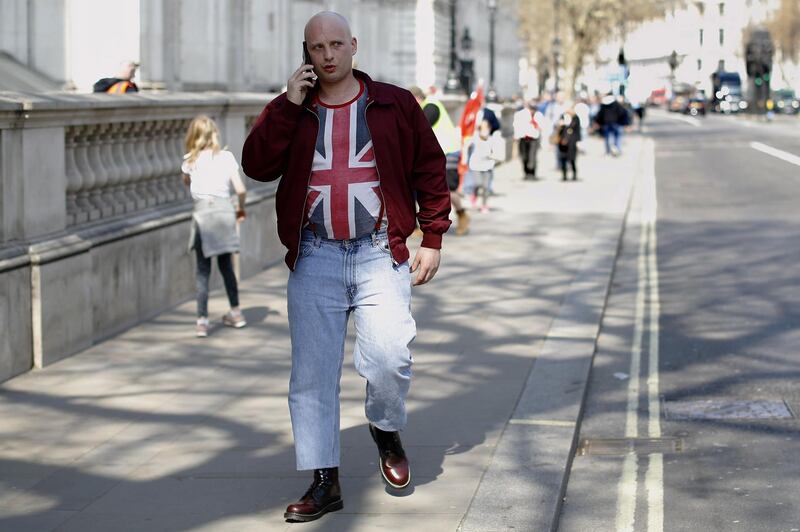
664,400,794,420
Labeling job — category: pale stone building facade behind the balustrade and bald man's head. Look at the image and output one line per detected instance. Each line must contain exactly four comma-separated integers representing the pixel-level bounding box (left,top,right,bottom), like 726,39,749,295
0,0,520,96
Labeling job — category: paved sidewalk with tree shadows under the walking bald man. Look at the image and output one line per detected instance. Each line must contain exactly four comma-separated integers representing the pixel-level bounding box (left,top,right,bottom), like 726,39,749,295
0,136,641,532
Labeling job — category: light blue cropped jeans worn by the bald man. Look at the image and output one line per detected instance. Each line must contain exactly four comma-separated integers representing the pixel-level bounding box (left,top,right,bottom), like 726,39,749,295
288,231,417,470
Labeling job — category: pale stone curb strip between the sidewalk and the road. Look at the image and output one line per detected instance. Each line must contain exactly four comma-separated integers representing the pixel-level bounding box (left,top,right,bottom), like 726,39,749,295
458,139,645,532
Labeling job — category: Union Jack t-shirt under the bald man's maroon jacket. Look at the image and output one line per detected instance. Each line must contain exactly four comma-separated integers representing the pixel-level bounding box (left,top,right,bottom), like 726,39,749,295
306,82,384,240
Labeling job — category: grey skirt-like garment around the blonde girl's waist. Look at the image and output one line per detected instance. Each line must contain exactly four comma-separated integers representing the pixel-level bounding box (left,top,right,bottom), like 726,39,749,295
189,198,239,258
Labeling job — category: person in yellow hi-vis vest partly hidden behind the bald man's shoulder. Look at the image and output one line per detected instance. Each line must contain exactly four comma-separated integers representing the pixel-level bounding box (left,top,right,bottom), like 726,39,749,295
409,86,469,235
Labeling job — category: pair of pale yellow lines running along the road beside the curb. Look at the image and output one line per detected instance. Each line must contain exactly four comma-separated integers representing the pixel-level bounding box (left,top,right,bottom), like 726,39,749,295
615,141,664,532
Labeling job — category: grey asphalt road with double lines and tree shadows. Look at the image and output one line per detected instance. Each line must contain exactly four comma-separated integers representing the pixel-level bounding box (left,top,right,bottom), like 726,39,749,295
559,113,800,532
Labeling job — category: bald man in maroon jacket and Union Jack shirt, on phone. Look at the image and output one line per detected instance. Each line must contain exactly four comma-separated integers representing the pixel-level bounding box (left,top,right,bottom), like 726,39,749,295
242,12,450,521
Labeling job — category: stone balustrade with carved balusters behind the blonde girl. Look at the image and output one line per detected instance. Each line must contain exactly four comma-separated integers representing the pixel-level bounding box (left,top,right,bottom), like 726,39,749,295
0,93,282,381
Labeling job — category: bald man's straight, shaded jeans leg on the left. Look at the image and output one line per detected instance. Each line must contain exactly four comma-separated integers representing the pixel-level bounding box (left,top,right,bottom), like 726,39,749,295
287,239,349,470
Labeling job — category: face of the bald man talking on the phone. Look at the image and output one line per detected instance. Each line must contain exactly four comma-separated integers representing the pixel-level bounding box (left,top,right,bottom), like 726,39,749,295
306,18,358,83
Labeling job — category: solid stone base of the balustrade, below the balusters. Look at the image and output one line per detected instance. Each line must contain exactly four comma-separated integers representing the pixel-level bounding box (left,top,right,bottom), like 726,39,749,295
0,190,285,382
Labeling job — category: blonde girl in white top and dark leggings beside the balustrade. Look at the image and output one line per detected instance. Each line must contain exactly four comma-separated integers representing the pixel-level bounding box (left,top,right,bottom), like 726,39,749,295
181,115,247,338
